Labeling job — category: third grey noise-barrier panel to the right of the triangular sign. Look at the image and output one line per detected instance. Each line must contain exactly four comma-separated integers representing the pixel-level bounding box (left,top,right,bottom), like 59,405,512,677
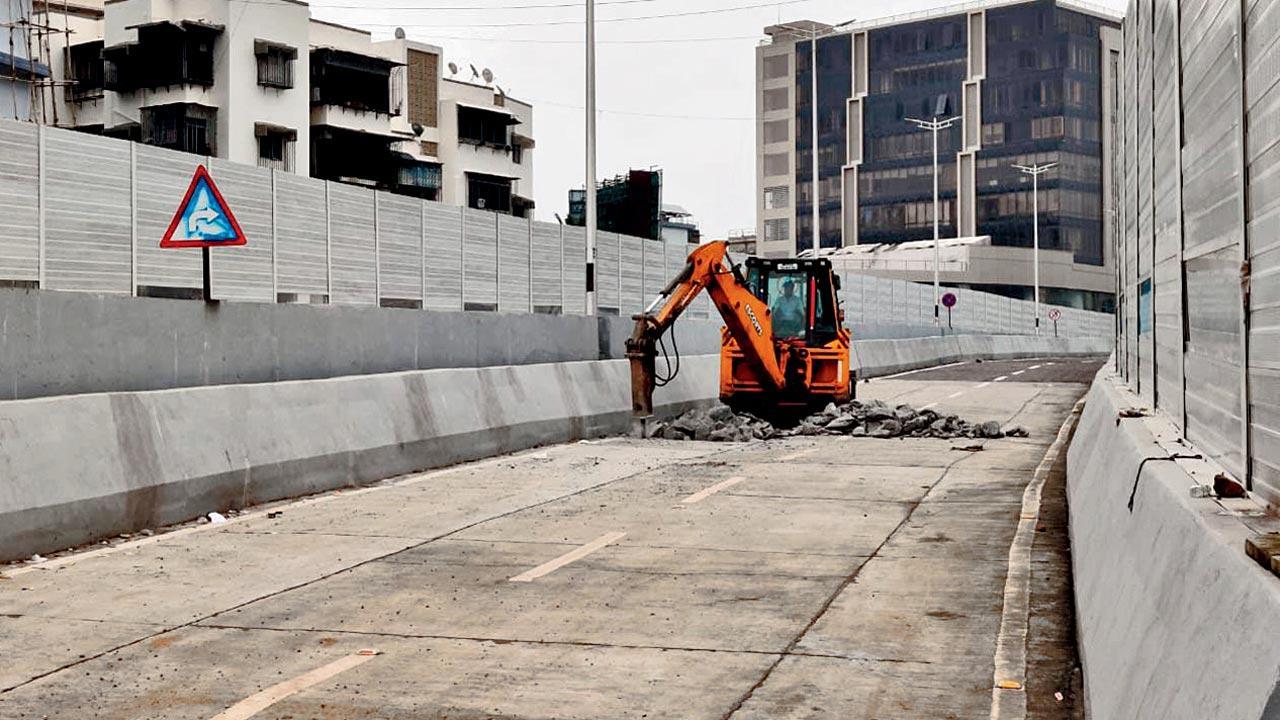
329,182,378,305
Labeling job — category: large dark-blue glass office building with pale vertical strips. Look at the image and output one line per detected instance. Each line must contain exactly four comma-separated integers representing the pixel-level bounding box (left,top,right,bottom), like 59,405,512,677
755,0,1120,309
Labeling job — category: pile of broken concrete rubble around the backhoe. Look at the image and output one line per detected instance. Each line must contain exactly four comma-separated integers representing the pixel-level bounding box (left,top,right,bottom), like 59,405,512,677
650,400,1027,442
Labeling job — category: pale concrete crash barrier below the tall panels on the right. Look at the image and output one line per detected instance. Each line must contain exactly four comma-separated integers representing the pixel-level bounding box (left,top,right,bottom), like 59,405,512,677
1068,369,1280,720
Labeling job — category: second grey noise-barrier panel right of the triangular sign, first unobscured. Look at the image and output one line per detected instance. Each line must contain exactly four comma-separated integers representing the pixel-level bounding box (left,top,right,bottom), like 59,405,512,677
275,172,329,295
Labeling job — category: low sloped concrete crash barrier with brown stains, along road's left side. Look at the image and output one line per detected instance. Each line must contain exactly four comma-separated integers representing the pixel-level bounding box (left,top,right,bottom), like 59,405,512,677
0,337,1111,560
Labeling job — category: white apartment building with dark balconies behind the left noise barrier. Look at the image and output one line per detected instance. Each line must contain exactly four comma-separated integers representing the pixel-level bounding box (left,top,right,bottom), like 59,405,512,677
27,0,534,215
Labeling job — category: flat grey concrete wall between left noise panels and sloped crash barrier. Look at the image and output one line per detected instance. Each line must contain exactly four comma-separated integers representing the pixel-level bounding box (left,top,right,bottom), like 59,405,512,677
0,288,719,400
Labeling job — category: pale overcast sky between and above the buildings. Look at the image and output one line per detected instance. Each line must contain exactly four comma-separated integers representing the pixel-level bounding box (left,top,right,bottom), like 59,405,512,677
311,0,1125,237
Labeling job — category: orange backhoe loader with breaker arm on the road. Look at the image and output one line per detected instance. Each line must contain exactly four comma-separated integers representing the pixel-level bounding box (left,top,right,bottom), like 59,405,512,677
627,242,851,418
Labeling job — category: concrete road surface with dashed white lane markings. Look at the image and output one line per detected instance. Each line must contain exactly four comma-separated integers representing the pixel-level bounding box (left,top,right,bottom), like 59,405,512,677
0,360,1097,720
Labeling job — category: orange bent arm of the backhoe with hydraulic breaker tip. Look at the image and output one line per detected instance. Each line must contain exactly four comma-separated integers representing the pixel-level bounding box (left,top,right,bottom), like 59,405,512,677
627,241,786,418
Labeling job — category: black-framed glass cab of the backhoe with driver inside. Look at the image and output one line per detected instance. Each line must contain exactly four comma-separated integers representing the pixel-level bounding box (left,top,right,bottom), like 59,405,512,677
744,258,841,347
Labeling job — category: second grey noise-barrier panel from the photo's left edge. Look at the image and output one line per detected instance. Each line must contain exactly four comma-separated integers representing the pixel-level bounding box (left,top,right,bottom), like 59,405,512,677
40,128,133,295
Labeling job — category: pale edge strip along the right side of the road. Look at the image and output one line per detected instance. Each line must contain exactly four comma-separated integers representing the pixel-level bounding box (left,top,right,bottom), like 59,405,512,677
991,400,1084,720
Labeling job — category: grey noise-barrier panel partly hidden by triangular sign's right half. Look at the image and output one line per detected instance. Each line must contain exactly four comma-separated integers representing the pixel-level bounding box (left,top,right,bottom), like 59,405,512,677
209,158,272,302
